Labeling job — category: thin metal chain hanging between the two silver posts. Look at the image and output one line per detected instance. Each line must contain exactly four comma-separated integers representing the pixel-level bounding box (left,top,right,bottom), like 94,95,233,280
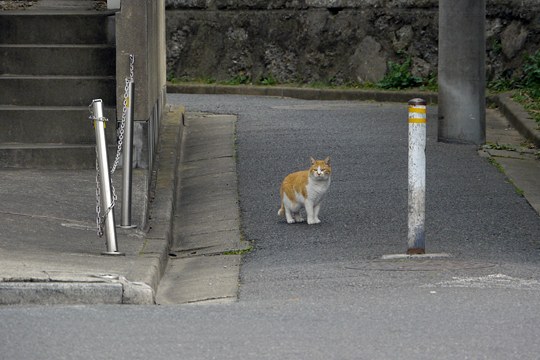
90,54,135,237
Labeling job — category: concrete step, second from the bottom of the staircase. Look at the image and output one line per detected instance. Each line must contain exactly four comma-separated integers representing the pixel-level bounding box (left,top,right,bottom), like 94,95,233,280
0,105,116,146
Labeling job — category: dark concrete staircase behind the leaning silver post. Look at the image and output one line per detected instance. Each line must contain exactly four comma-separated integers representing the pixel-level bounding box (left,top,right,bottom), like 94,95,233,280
0,0,116,169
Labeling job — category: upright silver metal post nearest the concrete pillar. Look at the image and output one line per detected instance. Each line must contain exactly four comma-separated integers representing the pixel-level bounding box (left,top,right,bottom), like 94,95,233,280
120,81,137,229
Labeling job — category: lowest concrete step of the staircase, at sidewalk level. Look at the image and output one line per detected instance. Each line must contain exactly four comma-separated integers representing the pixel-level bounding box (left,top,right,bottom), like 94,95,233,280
0,143,116,169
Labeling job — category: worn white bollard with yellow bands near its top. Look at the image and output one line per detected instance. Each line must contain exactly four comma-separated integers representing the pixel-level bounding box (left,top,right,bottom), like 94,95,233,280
407,99,426,255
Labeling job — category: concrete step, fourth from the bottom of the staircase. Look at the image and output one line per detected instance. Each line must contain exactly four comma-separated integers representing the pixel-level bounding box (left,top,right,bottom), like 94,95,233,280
0,44,116,76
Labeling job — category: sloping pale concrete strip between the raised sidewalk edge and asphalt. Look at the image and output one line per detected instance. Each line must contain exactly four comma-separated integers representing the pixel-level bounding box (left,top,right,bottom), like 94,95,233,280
156,112,251,304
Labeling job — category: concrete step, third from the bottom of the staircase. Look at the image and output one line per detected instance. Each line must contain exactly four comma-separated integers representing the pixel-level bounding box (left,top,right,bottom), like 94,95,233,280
0,75,116,106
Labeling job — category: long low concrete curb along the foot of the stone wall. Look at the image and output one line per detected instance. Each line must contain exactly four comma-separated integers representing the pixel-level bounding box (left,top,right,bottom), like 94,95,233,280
167,83,540,146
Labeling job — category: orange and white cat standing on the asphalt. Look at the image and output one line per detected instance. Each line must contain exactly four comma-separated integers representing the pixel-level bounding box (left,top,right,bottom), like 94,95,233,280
278,157,332,225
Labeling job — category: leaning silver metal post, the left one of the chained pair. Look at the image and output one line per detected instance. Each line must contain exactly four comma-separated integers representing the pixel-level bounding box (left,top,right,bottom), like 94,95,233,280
92,99,124,255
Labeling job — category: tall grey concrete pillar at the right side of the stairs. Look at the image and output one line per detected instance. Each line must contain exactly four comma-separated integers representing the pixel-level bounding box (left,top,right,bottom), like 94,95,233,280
116,0,166,169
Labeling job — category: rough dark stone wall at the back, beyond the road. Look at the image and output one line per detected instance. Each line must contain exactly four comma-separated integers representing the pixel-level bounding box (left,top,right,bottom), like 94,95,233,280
166,0,540,85
